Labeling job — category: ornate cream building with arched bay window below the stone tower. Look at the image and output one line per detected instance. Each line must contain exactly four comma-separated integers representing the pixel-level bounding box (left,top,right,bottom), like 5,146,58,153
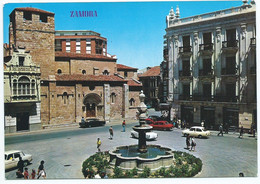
4,47,41,133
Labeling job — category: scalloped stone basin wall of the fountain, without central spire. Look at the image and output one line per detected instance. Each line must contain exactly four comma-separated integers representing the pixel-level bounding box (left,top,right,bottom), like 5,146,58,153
109,145,174,171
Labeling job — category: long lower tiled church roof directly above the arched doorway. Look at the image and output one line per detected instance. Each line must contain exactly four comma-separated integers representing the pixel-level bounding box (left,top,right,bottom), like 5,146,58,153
55,74,127,82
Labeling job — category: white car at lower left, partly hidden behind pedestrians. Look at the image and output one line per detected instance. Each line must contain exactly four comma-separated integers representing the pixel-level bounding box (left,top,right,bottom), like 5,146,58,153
5,150,32,170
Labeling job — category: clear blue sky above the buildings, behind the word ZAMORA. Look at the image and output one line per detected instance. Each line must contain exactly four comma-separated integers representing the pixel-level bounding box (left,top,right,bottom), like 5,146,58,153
3,0,242,69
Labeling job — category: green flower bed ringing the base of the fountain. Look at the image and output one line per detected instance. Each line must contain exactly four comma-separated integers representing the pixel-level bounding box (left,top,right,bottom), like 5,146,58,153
82,151,202,178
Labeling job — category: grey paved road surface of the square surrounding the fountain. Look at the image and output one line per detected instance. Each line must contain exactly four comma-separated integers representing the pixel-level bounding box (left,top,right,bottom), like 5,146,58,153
5,119,257,179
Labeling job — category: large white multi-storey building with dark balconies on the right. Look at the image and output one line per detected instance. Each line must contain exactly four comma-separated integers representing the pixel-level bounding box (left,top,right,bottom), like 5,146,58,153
166,1,256,129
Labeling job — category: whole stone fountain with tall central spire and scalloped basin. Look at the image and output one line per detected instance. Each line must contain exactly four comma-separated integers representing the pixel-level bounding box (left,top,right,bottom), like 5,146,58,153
109,91,174,171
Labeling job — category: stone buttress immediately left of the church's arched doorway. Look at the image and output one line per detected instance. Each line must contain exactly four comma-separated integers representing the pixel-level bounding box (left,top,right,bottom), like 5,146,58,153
75,84,83,122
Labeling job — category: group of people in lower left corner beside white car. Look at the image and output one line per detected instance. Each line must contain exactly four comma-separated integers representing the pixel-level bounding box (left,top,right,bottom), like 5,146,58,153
16,157,46,179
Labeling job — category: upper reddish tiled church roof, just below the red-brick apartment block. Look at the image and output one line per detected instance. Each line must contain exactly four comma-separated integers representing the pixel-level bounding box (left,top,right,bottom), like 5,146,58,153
55,51,117,61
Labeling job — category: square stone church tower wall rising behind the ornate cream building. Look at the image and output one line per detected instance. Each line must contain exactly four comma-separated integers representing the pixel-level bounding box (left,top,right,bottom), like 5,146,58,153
10,11,56,79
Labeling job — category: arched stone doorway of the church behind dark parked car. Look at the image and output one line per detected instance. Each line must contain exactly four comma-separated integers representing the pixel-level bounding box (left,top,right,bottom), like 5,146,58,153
83,93,102,117
